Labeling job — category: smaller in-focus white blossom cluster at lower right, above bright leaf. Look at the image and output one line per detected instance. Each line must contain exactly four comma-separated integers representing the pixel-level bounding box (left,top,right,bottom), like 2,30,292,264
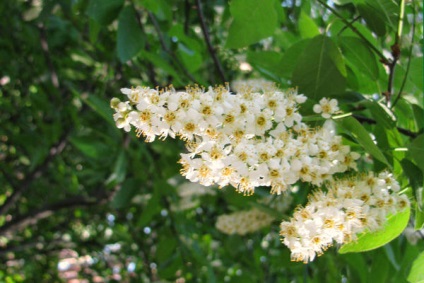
280,172,409,263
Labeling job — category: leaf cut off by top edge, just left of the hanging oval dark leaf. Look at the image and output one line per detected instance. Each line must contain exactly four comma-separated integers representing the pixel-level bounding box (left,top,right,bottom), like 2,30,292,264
87,0,124,25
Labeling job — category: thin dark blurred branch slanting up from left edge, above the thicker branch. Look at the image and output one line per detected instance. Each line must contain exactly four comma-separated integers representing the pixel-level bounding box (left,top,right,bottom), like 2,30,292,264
0,132,68,215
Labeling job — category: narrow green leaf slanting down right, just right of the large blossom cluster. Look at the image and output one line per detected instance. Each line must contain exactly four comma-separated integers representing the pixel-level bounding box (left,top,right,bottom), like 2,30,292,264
336,117,391,167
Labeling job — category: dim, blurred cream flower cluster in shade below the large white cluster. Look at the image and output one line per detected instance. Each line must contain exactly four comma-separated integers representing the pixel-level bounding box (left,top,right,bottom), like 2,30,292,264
215,208,275,236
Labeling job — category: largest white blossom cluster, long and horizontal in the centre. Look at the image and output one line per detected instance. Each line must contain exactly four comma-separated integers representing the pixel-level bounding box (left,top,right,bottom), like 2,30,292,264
111,83,359,195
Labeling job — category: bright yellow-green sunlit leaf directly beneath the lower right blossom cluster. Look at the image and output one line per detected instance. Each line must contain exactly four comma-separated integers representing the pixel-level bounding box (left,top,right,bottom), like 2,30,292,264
339,207,411,254
